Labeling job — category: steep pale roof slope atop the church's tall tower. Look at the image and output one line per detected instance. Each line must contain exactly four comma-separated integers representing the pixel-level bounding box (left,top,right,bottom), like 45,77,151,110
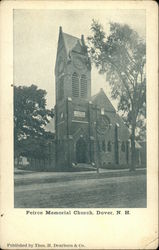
62,32,82,54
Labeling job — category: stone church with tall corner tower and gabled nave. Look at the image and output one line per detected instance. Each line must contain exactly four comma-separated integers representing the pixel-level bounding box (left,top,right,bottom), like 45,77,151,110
47,27,130,169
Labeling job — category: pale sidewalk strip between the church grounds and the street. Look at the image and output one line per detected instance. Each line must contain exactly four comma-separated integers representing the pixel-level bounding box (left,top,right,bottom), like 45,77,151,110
14,168,146,186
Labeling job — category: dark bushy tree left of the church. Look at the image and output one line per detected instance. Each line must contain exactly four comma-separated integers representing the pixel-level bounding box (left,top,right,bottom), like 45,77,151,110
14,85,54,166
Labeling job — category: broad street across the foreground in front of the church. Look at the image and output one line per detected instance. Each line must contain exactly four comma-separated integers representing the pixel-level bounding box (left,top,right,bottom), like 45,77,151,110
14,171,146,208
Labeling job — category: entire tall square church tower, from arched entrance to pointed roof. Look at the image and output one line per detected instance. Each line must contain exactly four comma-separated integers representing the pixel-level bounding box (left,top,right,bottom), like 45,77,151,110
55,27,93,168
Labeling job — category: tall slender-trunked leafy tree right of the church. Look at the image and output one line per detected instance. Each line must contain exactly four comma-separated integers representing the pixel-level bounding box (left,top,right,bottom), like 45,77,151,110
88,20,146,170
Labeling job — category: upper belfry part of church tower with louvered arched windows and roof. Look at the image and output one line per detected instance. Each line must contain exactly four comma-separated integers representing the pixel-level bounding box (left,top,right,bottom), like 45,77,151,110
55,27,91,104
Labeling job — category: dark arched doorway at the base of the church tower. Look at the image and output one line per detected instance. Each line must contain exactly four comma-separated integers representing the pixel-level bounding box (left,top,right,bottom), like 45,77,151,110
76,137,87,163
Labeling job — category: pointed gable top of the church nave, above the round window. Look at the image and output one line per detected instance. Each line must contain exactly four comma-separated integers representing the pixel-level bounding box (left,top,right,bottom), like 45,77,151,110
91,88,116,112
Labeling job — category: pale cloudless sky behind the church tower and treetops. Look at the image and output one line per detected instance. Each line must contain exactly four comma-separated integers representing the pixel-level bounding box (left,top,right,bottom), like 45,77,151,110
13,9,146,108
